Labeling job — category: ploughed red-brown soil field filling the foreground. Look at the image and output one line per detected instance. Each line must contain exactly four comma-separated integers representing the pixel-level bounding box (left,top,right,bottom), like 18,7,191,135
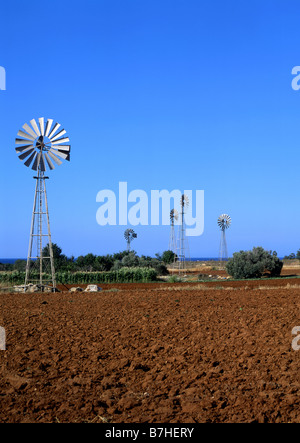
0,278,300,423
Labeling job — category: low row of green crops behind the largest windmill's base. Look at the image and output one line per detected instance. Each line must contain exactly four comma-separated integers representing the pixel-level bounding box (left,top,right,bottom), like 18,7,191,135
0,268,158,285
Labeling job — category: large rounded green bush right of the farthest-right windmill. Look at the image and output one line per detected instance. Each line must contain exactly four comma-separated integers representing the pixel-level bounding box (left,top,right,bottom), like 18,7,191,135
226,247,283,279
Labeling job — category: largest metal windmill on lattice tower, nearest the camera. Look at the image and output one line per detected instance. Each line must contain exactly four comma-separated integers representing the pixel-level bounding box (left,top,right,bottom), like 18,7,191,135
15,117,71,290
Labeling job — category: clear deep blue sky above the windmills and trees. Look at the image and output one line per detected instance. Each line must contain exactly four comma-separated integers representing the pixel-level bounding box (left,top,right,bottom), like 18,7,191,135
0,0,300,258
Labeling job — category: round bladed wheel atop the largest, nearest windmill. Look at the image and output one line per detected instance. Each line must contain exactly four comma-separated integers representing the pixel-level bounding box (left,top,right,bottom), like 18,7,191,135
15,117,71,172
